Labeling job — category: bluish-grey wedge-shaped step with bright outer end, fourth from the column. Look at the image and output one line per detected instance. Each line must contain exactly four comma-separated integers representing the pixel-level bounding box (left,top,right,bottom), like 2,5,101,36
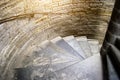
51,36,84,60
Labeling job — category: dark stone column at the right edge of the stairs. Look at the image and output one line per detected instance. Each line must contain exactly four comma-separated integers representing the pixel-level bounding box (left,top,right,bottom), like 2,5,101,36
101,0,120,80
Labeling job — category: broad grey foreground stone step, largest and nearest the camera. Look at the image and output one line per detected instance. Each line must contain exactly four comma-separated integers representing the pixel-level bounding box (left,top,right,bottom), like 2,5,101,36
15,54,102,80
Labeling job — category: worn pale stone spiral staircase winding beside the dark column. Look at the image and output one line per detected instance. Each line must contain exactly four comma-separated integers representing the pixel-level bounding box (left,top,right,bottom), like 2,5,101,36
14,35,119,80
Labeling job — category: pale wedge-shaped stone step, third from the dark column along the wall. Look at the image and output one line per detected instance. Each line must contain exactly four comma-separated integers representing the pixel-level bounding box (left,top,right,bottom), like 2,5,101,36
63,35,85,58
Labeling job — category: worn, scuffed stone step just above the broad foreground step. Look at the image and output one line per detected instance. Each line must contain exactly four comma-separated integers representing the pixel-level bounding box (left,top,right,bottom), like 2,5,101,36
28,53,81,69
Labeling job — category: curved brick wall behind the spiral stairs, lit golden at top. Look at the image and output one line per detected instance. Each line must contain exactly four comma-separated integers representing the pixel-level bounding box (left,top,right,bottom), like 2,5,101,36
0,0,114,80
